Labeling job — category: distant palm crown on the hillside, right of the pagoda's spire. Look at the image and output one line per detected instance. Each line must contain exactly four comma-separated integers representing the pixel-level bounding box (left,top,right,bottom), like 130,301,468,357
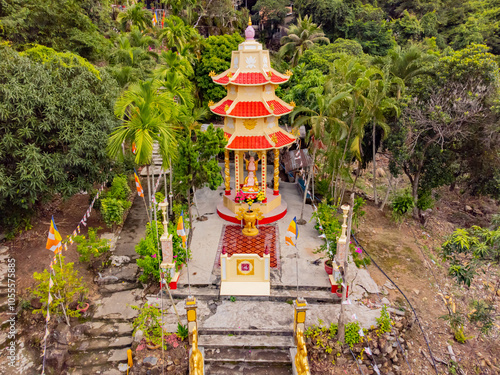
279,16,330,66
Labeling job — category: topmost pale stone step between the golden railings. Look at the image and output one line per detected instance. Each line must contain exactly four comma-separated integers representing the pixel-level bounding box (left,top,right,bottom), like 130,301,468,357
198,333,295,350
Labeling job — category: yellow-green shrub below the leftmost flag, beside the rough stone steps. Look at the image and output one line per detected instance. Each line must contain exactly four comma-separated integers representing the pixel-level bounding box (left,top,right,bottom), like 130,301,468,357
29,255,87,317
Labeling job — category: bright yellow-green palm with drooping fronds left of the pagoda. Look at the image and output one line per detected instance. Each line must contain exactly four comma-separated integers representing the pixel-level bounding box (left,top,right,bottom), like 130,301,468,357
108,79,178,207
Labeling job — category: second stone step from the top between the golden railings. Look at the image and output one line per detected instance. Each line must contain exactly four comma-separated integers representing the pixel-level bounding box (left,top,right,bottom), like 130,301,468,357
205,347,290,365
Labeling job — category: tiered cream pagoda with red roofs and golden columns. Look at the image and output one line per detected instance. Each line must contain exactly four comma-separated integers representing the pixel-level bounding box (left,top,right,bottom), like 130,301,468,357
209,22,295,224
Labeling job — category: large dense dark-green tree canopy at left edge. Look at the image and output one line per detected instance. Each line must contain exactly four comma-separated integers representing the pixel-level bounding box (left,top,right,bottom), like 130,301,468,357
0,47,118,229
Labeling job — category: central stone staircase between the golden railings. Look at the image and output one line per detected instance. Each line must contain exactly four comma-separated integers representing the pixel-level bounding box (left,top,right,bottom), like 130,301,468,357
199,329,294,375
